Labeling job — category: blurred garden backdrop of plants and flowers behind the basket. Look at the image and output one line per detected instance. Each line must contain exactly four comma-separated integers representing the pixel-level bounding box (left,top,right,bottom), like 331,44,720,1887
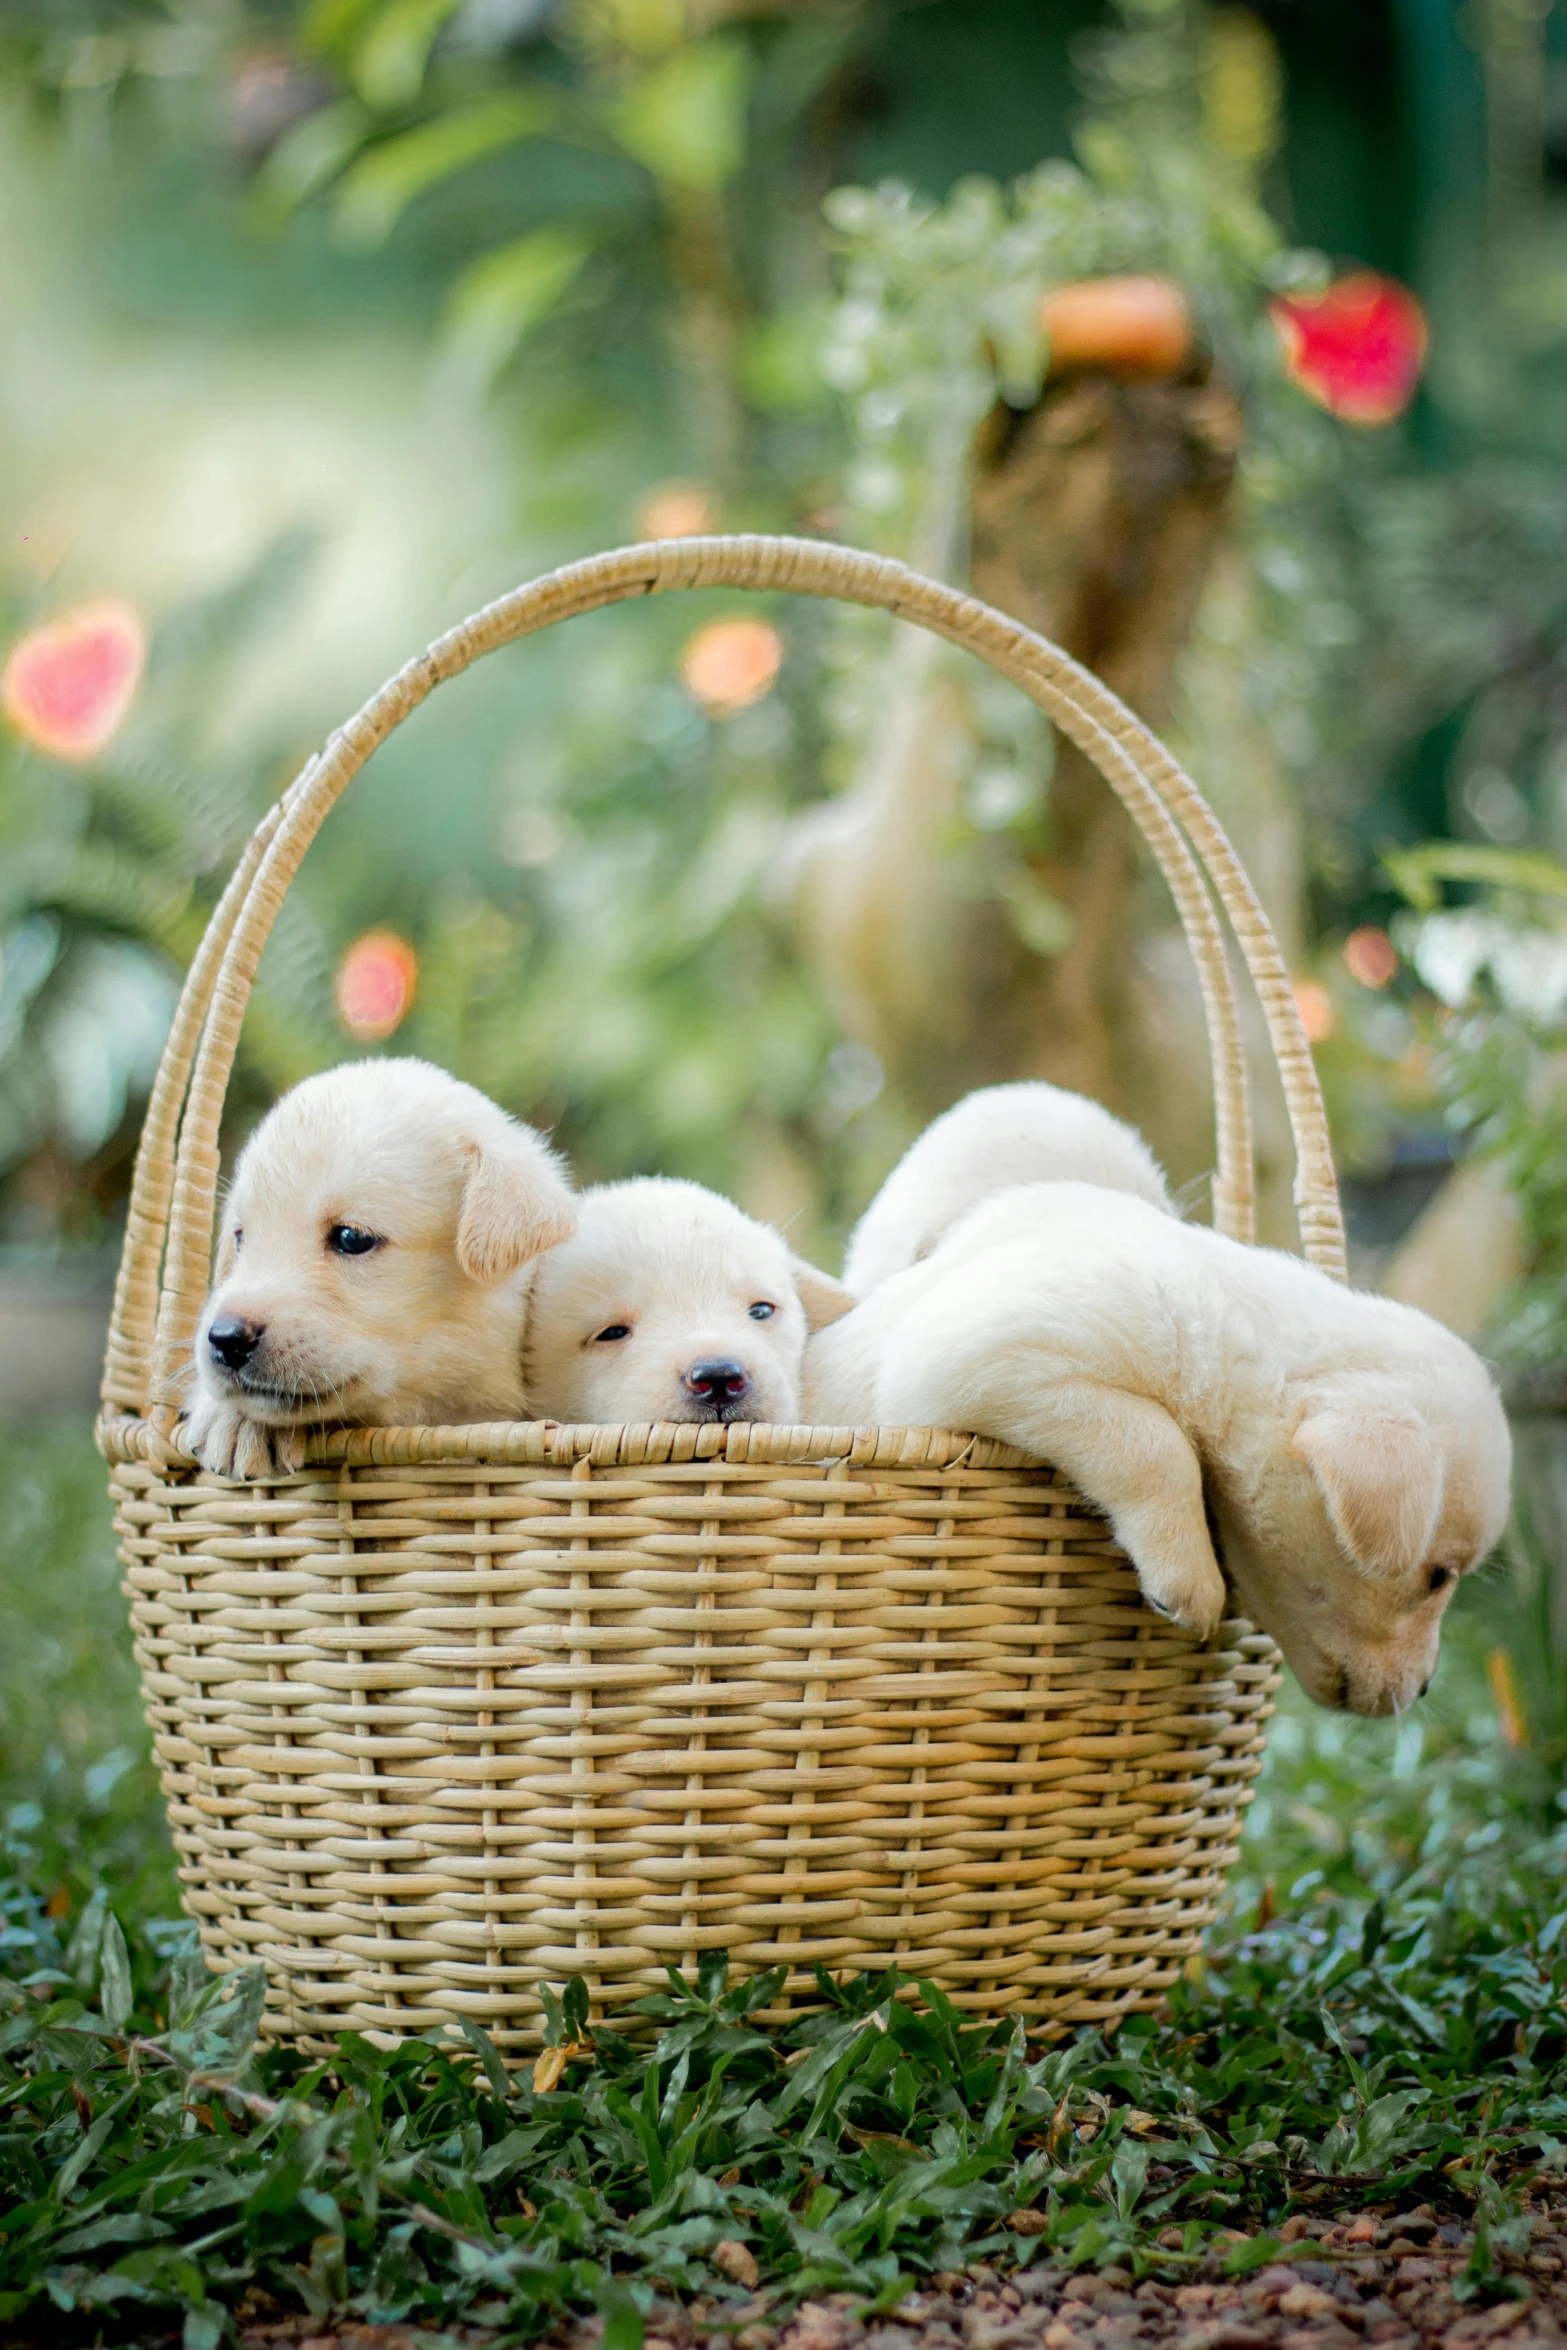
0,0,1567,1851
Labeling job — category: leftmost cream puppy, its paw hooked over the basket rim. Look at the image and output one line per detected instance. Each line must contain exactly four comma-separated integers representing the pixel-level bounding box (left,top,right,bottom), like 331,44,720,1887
183,1060,576,1476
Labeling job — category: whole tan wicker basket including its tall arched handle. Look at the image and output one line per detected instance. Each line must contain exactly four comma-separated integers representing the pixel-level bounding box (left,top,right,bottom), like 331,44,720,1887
99,538,1344,2056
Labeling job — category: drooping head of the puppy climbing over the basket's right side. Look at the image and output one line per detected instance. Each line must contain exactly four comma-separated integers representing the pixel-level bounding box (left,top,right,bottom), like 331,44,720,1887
1217,1353,1511,1713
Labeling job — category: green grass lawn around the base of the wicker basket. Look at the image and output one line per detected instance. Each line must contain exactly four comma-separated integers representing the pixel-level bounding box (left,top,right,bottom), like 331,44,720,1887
0,1429,1567,2350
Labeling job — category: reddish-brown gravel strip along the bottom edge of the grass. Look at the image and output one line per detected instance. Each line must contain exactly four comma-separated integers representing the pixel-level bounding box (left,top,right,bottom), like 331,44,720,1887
217,2202,1567,2350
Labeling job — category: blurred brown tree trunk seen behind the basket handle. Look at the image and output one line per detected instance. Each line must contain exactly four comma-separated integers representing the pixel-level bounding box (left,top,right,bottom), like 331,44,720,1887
796,374,1240,1165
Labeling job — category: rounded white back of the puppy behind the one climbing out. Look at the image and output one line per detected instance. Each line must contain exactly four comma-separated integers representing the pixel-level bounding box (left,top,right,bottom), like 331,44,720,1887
843,1081,1175,1297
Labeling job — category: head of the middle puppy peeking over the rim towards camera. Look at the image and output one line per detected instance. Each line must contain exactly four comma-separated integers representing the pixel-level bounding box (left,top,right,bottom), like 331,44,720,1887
524,1177,853,1424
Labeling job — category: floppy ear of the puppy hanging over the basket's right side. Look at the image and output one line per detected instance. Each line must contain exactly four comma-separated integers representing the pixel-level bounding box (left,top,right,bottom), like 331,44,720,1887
1294,1382,1445,1575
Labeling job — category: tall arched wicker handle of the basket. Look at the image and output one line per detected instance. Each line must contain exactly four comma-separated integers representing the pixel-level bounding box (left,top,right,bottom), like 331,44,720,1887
103,536,1344,1434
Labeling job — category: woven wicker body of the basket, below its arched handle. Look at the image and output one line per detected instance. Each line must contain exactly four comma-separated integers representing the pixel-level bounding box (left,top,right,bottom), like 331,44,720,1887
115,1431,1278,2047
